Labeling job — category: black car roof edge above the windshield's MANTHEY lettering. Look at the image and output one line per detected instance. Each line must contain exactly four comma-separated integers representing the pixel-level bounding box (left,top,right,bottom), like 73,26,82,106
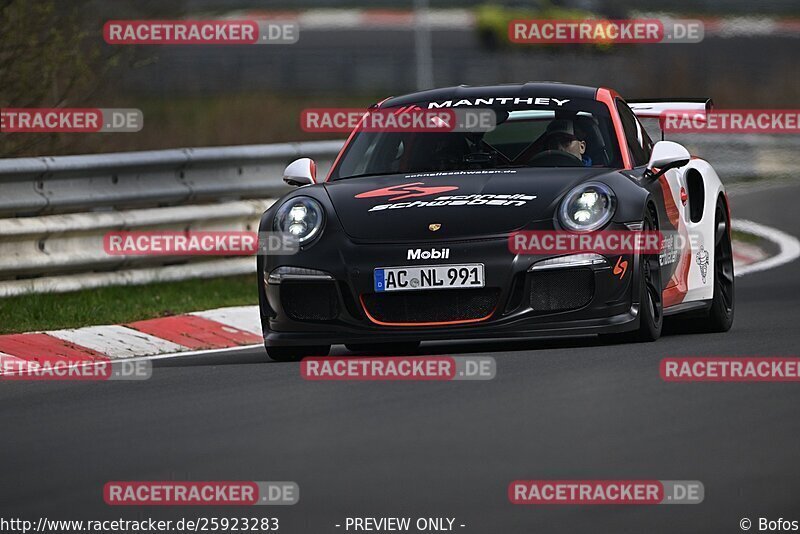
380,82,597,107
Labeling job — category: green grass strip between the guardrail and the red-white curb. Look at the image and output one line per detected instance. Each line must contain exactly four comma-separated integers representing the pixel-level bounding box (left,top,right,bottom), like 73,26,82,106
0,275,258,334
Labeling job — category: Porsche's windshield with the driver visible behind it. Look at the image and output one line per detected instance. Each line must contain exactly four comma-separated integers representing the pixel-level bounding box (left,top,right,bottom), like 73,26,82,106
331,98,622,180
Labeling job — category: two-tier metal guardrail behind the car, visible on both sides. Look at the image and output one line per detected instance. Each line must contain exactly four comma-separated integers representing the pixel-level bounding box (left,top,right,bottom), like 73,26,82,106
0,135,800,297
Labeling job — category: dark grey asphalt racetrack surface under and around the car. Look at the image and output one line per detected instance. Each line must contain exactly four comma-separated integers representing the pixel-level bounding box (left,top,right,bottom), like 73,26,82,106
0,185,800,534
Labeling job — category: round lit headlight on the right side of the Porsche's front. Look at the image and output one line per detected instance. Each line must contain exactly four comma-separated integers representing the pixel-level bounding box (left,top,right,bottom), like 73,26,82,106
558,182,617,232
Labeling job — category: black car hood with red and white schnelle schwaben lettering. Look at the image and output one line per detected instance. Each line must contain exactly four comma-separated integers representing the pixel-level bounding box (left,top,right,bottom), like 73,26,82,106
324,167,620,241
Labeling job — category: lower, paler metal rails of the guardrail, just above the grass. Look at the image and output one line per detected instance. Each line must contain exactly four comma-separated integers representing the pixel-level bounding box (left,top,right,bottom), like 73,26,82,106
0,199,274,297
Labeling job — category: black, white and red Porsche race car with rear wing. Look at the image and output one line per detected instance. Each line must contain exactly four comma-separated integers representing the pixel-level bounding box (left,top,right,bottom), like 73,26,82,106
258,83,734,361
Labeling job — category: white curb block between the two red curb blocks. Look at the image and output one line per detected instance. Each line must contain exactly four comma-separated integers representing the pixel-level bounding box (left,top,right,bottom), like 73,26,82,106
47,325,189,359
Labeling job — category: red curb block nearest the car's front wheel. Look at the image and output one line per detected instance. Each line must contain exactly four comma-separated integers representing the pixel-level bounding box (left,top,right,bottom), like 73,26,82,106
125,315,263,350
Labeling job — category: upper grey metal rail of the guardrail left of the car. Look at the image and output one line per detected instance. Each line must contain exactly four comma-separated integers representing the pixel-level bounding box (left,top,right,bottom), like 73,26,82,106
0,141,342,217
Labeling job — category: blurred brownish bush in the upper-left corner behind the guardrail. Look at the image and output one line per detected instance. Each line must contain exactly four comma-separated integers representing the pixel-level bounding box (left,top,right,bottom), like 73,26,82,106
0,0,182,157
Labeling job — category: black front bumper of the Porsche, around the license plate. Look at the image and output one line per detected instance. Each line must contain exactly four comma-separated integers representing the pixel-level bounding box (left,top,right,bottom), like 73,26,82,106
261,237,639,346
